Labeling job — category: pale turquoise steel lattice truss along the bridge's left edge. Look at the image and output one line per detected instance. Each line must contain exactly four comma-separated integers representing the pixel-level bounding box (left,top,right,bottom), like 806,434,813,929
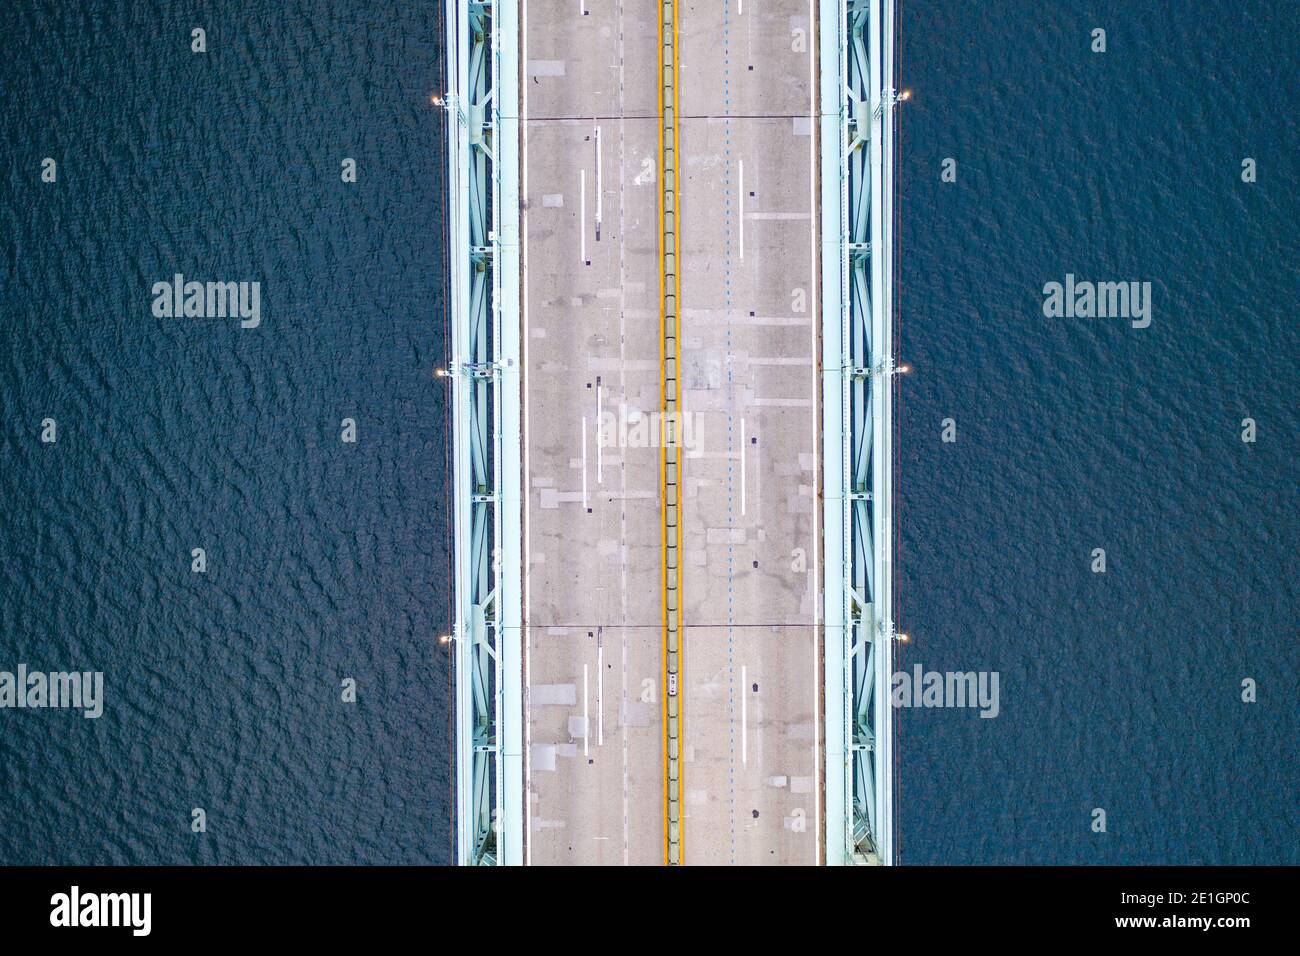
445,0,520,865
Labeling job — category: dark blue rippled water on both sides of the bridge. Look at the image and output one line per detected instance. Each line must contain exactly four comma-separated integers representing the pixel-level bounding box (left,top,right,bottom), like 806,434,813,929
0,0,1300,864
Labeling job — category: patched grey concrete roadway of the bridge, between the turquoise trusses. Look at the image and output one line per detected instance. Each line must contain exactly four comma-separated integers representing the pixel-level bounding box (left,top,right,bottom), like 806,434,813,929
521,0,823,864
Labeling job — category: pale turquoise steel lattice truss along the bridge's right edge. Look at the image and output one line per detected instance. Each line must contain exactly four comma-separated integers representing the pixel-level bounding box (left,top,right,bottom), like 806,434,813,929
823,0,894,864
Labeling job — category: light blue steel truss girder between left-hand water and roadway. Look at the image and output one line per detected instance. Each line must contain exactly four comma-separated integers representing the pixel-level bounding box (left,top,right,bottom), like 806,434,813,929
445,0,517,865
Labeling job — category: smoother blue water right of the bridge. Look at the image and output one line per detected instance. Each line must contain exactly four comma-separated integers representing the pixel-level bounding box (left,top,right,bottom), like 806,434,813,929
898,0,1300,864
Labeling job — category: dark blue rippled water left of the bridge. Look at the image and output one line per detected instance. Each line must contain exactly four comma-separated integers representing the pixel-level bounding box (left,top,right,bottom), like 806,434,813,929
0,0,450,864
